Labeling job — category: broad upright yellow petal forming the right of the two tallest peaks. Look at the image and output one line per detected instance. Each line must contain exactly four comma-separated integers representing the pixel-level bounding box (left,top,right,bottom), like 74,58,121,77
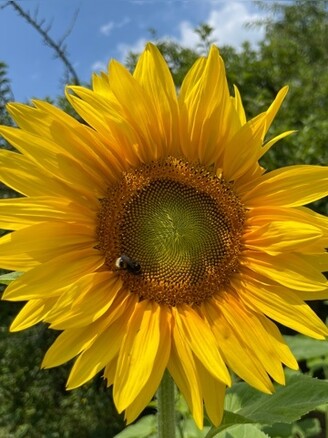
179,46,240,165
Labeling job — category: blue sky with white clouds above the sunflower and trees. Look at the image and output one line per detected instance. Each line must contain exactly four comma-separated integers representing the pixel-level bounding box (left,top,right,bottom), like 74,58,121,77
0,0,263,102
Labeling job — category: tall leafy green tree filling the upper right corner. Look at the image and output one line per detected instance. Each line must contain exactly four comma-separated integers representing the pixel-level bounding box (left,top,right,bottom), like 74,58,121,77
260,0,328,170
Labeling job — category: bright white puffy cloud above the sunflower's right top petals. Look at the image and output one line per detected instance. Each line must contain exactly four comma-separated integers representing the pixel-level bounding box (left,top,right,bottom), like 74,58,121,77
178,2,264,49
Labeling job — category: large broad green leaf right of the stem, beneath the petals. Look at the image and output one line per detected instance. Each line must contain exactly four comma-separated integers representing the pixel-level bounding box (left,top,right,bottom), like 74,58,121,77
225,372,328,425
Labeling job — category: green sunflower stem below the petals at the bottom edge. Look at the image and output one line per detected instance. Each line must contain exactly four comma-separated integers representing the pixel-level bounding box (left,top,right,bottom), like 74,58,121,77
157,370,176,438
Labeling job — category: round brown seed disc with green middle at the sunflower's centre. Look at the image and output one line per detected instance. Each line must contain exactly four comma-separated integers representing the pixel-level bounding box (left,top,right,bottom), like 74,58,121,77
97,157,245,306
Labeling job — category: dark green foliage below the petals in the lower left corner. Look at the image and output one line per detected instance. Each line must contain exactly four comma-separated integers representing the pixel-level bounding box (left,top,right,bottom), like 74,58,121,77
0,314,124,438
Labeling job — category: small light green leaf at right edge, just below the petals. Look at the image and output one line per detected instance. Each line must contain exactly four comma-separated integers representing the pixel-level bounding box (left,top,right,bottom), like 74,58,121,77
284,335,328,361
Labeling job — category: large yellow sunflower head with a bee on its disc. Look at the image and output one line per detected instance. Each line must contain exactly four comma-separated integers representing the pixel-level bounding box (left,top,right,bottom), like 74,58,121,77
0,44,328,427
